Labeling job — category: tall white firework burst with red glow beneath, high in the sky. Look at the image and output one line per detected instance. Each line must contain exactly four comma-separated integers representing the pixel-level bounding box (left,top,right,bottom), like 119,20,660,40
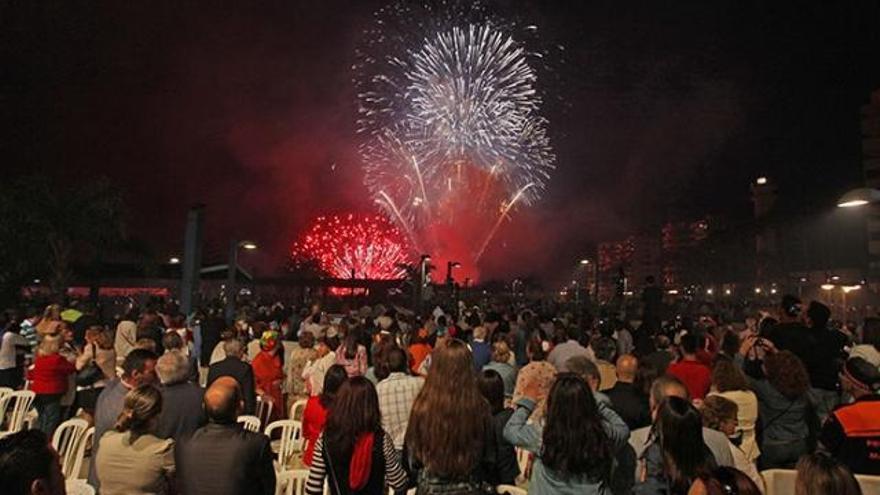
356,0,555,272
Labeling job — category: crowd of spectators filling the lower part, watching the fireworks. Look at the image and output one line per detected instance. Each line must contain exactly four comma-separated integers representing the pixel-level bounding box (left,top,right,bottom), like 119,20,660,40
0,290,880,495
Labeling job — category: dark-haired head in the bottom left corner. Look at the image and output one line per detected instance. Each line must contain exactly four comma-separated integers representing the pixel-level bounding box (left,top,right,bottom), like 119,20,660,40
0,430,65,495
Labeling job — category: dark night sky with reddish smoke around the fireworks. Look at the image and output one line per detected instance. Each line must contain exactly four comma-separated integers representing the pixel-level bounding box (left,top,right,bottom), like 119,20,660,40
0,1,880,278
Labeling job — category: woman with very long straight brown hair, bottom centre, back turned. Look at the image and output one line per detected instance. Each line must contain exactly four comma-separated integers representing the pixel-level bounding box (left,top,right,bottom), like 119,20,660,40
405,339,496,494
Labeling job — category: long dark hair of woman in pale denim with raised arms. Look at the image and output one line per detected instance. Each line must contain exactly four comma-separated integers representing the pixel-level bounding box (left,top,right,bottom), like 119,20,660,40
541,373,613,482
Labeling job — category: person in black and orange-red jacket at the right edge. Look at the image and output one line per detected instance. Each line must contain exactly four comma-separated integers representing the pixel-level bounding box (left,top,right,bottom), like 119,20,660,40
819,357,880,475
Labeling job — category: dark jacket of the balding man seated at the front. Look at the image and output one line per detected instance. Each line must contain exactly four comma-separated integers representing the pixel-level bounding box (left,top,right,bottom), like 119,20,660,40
175,423,275,495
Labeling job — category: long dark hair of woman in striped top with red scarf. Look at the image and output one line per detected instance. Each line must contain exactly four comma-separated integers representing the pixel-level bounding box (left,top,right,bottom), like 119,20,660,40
324,376,382,459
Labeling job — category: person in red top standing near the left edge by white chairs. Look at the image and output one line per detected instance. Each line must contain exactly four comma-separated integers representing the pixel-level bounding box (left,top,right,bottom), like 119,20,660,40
28,334,76,435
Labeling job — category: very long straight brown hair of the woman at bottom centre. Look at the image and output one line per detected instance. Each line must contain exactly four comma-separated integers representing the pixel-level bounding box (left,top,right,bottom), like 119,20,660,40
406,339,490,476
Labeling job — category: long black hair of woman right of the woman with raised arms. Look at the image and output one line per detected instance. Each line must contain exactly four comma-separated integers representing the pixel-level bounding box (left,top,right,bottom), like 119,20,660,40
654,396,716,494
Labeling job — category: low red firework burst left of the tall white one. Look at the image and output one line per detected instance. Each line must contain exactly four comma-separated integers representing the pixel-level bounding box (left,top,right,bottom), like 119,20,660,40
291,213,410,280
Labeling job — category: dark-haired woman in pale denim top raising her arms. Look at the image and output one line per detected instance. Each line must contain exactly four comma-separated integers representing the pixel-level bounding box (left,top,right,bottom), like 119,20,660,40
504,373,629,494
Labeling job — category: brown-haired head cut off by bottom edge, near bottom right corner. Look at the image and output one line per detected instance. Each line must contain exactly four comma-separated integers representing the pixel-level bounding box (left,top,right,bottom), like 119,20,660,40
794,452,862,495
